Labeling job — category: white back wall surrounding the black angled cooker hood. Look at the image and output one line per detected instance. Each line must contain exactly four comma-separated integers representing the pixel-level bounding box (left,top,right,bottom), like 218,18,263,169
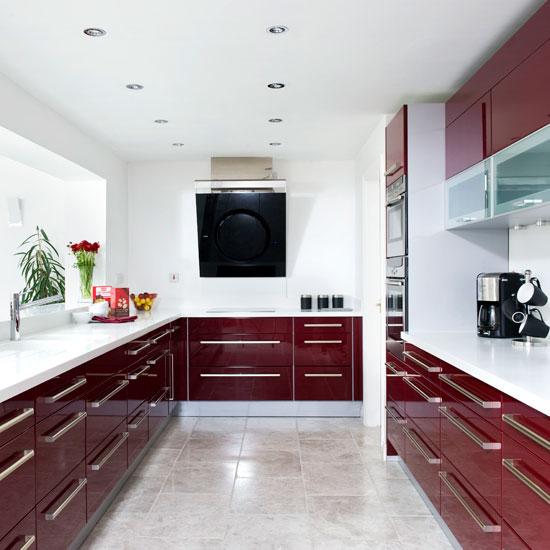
128,161,357,307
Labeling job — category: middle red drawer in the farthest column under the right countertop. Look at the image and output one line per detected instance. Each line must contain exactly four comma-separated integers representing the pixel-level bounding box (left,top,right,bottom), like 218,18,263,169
403,375,442,448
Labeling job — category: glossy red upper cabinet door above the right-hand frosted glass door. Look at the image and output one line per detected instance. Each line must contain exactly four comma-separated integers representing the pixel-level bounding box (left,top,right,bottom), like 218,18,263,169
492,42,550,152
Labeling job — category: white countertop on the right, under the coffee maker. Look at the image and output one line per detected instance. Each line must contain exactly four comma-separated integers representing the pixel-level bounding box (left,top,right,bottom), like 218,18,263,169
402,332,550,416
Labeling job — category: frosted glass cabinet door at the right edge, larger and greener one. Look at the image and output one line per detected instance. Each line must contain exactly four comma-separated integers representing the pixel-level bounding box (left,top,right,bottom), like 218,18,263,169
493,125,550,215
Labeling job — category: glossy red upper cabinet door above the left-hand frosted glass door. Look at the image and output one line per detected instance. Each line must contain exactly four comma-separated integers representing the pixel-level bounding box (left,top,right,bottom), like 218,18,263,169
445,94,491,178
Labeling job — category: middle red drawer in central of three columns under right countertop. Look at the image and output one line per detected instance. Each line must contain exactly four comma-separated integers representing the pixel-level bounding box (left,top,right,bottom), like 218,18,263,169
440,393,502,513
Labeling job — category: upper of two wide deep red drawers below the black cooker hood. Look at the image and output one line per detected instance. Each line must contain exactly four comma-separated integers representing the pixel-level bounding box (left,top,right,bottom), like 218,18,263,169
189,333,292,367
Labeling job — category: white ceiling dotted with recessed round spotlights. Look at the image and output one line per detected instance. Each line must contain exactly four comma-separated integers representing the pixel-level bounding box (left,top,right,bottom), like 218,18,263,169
0,0,543,160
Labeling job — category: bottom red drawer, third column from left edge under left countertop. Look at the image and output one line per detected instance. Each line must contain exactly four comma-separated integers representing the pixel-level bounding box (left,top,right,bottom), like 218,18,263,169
86,421,129,520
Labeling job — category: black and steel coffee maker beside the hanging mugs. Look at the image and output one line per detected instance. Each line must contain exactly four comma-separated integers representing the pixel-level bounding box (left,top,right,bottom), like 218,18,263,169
477,272,525,338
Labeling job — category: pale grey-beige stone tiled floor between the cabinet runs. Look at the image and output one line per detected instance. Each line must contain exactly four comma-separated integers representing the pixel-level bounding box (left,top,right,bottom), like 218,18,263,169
85,418,451,550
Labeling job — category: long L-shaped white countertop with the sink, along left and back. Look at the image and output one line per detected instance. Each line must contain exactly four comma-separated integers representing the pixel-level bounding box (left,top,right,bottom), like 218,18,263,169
0,308,361,402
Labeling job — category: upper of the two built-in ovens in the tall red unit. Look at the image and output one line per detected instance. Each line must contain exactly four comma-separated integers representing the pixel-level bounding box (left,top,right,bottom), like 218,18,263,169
386,176,407,258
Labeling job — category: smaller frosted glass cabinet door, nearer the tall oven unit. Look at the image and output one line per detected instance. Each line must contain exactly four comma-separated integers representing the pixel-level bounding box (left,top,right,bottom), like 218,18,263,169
445,161,491,229
